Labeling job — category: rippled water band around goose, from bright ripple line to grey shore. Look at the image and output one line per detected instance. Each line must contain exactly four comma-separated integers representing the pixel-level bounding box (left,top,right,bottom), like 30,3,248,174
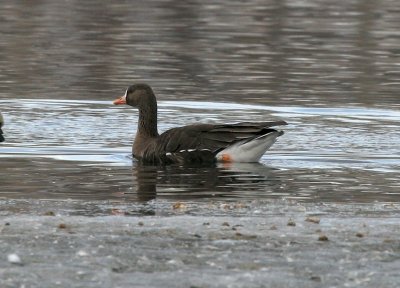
0,99,400,202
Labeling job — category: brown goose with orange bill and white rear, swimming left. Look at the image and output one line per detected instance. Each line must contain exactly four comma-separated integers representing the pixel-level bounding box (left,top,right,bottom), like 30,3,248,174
114,84,286,164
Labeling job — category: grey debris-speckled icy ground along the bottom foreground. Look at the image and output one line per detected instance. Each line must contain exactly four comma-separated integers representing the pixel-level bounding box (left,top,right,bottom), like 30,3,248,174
0,200,400,288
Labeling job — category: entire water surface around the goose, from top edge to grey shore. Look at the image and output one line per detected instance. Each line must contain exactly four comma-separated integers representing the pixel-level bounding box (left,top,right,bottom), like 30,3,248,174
0,0,400,203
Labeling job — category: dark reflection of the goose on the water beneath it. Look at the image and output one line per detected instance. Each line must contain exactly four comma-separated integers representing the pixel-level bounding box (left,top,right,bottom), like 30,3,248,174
132,162,282,201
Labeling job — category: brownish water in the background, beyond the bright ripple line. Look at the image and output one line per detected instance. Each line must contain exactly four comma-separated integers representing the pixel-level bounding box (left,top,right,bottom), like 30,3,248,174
0,0,400,107
